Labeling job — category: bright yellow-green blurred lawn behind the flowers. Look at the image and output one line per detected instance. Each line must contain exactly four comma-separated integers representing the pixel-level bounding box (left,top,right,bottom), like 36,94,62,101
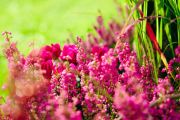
0,0,125,95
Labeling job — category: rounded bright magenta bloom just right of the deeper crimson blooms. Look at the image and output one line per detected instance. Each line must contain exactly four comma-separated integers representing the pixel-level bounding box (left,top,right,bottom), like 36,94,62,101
61,45,78,63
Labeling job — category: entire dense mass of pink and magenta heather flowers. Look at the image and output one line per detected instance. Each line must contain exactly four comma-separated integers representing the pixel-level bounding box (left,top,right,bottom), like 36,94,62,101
0,16,180,120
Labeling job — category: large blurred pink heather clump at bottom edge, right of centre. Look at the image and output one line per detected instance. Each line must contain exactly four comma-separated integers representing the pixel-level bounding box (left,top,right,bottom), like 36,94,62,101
114,84,150,120
